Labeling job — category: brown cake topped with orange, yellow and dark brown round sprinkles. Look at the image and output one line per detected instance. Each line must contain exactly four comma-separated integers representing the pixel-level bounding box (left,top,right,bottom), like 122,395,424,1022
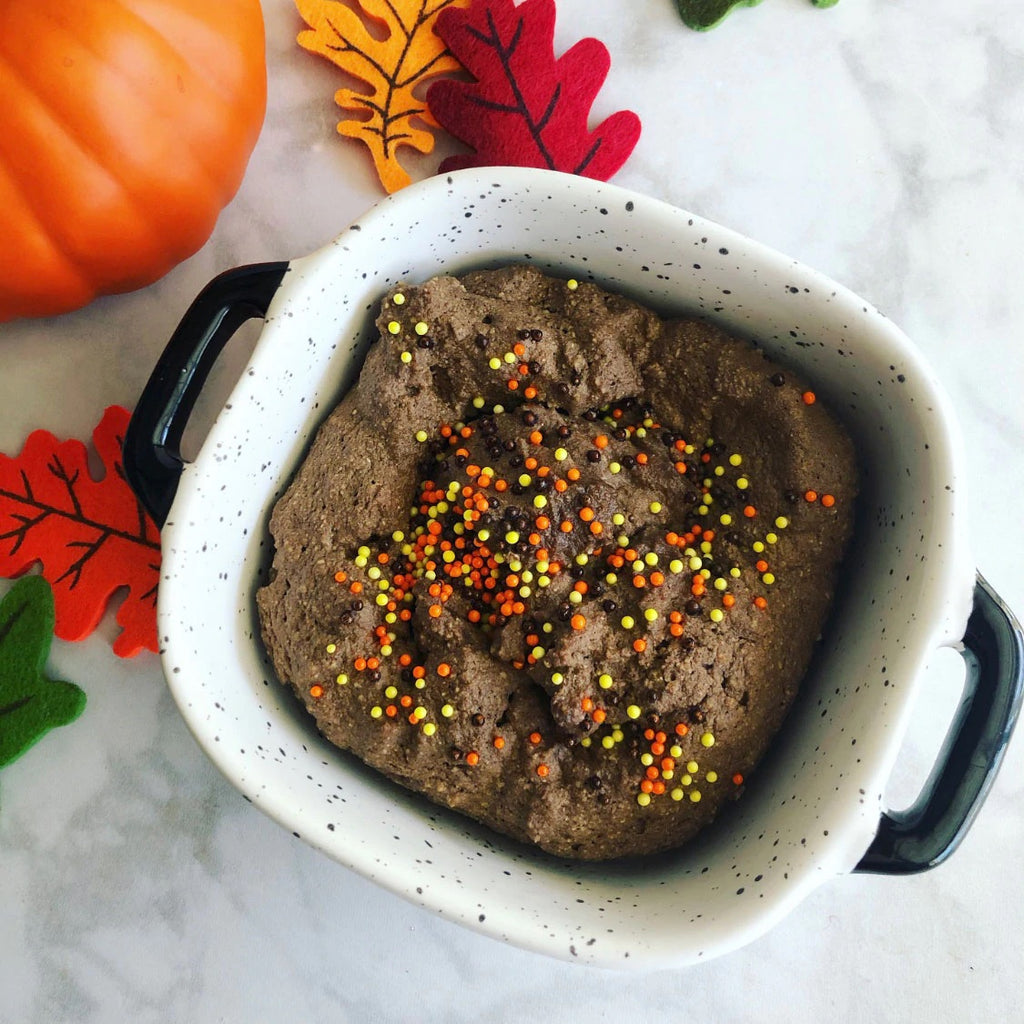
258,266,856,859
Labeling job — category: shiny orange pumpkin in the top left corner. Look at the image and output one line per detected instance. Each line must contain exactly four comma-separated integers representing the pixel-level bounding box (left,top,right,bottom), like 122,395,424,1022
0,0,266,321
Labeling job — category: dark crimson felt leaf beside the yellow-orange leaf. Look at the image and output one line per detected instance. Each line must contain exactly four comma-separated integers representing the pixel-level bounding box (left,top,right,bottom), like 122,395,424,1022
427,0,640,180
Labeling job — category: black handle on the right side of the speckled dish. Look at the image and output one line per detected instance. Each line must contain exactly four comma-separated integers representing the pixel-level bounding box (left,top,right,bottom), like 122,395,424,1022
854,573,1024,874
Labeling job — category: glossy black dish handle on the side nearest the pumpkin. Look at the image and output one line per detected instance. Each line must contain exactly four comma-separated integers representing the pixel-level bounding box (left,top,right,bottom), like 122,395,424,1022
123,263,288,526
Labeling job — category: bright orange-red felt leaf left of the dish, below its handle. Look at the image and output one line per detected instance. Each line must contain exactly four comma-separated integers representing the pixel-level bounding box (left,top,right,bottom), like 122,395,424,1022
0,406,160,657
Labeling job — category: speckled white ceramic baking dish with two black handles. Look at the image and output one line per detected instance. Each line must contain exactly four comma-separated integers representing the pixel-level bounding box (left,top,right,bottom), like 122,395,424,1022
125,168,1021,968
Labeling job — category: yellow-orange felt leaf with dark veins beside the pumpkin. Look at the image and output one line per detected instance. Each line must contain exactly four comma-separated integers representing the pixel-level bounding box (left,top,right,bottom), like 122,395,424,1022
295,0,468,193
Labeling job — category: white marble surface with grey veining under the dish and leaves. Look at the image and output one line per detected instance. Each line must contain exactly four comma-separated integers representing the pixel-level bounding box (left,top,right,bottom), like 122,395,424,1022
0,0,1024,1024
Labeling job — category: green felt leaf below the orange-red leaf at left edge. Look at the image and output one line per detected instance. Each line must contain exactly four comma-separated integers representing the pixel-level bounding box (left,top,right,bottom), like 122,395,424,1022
0,575,85,766
